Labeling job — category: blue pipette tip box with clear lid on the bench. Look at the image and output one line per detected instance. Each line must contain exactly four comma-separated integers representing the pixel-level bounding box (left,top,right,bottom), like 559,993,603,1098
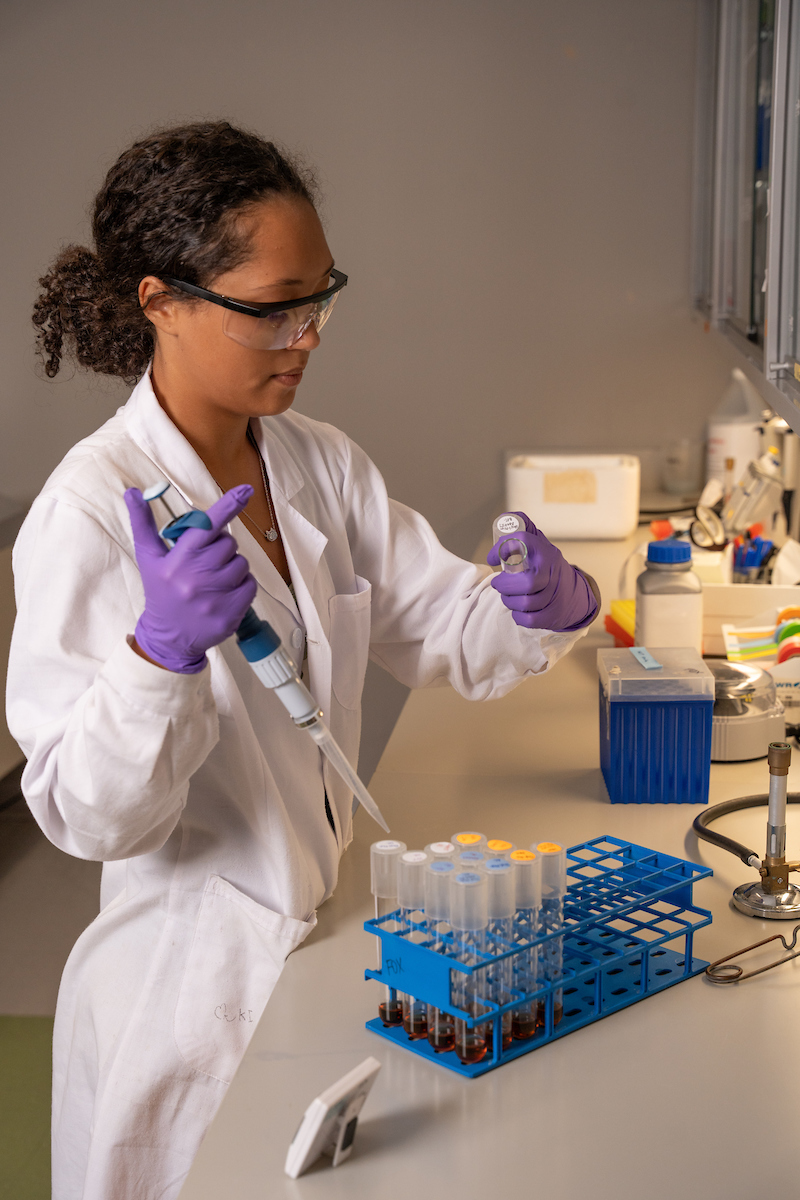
597,647,714,804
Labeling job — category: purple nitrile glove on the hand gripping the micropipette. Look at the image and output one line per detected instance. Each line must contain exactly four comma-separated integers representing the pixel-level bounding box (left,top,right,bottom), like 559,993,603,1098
125,484,255,674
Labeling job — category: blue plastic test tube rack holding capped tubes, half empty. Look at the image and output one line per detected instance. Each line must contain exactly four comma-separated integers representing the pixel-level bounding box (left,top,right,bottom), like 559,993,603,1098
363,836,712,1079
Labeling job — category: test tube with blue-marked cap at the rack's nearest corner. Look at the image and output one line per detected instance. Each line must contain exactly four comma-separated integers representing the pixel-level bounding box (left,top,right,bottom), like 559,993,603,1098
450,871,489,1063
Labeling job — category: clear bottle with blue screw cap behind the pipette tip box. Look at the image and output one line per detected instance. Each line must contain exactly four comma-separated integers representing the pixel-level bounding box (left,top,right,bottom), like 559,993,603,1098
633,538,703,654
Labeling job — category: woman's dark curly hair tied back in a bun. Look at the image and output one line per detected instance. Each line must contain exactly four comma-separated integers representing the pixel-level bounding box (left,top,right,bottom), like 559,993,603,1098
34,121,317,383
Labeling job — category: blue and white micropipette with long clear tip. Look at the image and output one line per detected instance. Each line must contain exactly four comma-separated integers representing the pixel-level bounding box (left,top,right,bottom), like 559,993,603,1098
142,481,389,833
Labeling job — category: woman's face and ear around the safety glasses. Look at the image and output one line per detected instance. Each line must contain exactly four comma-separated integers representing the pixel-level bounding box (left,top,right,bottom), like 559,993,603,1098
139,196,333,416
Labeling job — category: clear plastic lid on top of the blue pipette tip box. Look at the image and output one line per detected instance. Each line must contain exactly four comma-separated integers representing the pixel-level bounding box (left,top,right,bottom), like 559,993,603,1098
597,646,714,700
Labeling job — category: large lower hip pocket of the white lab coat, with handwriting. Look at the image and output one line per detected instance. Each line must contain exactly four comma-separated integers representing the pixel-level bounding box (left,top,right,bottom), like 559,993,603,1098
174,875,317,1084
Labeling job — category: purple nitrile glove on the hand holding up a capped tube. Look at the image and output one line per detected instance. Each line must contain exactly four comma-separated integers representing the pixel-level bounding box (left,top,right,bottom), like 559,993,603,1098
486,512,599,634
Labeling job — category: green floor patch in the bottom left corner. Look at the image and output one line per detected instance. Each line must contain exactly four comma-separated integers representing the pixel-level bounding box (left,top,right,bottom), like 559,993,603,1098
0,1016,53,1200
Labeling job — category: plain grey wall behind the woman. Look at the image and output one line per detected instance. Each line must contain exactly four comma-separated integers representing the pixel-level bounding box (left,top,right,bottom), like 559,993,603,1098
0,0,743,777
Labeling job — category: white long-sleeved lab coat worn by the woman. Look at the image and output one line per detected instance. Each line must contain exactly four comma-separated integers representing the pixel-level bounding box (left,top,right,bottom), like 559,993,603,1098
7,376,581,1200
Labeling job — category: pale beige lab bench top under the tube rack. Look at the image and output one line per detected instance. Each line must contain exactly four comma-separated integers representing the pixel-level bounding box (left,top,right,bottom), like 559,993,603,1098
181,535,800,1200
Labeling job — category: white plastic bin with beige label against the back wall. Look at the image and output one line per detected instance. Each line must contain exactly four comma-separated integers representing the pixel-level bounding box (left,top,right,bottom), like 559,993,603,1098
506,454,639,539
